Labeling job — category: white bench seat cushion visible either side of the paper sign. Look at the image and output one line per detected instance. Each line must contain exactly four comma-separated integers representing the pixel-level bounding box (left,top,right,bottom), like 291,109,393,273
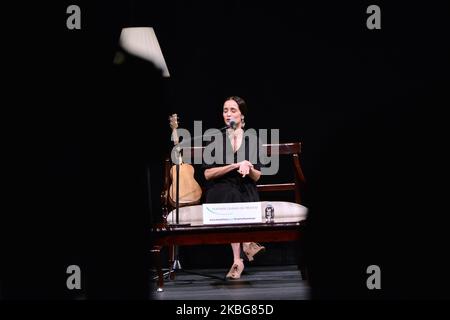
167,201,308,225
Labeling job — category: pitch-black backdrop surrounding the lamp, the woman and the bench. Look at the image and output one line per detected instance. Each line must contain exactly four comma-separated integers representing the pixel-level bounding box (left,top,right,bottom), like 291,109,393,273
1,1,450,299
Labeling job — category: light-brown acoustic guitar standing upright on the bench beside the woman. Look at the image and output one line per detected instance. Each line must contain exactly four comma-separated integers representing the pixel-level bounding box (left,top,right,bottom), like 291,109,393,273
169,114,202,205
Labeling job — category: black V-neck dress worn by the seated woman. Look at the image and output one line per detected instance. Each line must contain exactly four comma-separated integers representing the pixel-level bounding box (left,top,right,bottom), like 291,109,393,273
203,129,261,203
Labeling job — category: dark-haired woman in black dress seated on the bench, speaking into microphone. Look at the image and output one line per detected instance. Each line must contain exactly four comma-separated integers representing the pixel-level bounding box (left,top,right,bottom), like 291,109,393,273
204,96,265,279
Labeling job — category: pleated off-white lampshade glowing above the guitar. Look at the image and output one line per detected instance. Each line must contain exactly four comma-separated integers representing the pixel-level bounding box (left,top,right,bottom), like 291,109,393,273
119,27,170,78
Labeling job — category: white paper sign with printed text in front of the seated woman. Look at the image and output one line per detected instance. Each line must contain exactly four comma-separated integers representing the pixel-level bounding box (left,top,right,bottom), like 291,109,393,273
203,202,262,224
